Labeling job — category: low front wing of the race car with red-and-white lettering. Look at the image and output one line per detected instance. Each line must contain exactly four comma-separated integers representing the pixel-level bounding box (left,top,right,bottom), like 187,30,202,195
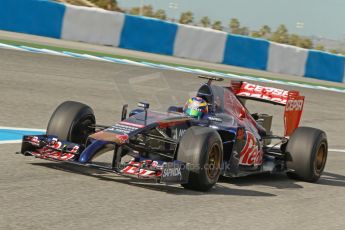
20,135,189,184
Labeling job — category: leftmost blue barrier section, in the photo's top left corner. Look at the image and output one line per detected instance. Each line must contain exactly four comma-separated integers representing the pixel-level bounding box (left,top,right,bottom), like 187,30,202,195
0,0,66,38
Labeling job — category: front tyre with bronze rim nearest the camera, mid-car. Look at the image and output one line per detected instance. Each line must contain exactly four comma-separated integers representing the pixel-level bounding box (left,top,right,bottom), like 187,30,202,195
177,126,223,191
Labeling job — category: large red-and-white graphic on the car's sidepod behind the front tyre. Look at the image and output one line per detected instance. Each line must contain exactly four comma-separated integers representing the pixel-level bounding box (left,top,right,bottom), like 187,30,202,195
240,131,263,165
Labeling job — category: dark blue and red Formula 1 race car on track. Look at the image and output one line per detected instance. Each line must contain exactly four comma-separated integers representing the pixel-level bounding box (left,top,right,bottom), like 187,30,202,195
21,76,328,191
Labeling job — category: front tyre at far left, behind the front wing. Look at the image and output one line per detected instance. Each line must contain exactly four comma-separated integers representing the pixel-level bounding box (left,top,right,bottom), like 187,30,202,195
47,101,96,144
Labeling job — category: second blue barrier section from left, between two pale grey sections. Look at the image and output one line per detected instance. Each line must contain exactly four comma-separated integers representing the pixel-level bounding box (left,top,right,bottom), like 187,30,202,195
120,15,177,55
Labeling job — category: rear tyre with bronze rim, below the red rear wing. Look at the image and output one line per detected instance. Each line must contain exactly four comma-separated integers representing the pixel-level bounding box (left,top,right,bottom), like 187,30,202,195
286,127,328,182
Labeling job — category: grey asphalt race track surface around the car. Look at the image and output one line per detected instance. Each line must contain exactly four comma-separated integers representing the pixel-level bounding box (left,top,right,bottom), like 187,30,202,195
0,49,345,230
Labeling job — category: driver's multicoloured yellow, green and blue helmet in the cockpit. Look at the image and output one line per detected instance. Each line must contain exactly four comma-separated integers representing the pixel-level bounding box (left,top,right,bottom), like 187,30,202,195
183,97,208,119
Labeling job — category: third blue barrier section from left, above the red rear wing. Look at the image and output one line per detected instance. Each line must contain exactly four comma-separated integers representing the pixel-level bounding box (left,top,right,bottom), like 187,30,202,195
223,34,269,70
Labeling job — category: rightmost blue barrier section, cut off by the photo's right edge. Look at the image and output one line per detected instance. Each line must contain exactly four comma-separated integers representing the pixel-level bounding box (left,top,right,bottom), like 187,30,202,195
304,50,345,82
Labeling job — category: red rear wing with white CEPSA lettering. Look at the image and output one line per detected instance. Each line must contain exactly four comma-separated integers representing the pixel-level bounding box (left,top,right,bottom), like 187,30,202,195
230,81,304,136
